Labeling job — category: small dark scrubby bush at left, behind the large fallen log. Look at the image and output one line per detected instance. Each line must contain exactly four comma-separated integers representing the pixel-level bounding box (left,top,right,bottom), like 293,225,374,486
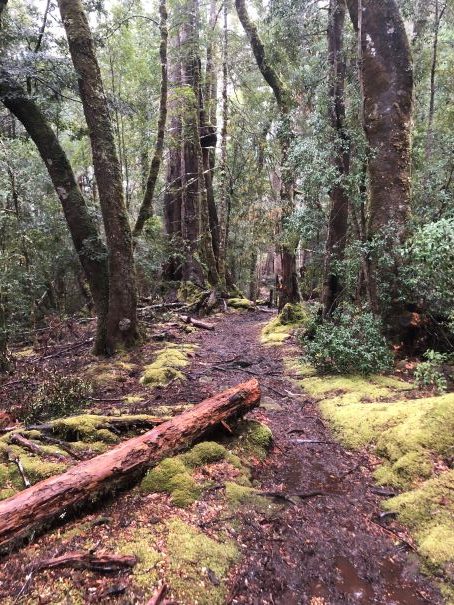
18,372,92,424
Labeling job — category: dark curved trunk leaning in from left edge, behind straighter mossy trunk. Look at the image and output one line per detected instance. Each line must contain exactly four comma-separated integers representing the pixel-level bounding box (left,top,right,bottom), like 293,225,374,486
0,70,109,354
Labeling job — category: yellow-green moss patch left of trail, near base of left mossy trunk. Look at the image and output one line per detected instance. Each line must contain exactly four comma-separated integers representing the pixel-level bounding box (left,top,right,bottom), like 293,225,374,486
140,345,194,387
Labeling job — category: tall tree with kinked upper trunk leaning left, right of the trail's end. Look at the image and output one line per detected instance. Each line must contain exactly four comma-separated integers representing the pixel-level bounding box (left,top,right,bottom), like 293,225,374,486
235,0,300,309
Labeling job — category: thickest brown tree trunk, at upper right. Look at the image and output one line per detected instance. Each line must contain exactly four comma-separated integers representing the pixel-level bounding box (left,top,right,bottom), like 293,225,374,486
347,0,413,313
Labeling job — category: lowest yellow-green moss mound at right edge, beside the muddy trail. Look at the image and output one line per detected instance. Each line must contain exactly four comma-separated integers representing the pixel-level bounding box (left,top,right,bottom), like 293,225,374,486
384,470,454,568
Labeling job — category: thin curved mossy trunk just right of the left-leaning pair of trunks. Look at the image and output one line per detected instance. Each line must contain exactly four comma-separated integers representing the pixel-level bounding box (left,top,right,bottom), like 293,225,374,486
133,0,168,238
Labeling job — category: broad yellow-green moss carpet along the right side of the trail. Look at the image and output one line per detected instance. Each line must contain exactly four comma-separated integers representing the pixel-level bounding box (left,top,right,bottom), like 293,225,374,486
290,360,454,591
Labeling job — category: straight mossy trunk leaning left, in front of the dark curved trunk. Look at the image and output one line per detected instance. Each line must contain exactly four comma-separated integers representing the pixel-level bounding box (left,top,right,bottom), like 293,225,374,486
58,0,138,353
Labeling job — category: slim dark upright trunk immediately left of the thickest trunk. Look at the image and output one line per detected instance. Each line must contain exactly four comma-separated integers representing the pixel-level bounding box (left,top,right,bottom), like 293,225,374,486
323,0,350,316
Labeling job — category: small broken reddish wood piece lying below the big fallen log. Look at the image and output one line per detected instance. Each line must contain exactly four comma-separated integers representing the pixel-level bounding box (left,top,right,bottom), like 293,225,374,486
35,552,137,573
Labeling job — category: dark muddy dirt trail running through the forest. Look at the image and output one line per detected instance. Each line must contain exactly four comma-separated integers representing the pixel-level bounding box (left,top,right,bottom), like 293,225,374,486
195,313,443,605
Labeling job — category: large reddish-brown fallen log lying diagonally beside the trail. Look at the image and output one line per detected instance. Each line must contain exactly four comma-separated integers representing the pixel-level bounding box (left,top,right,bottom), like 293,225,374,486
0,379,260,548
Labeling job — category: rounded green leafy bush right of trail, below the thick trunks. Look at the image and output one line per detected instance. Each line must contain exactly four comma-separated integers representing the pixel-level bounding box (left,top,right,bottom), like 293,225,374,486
300,310,393,375
